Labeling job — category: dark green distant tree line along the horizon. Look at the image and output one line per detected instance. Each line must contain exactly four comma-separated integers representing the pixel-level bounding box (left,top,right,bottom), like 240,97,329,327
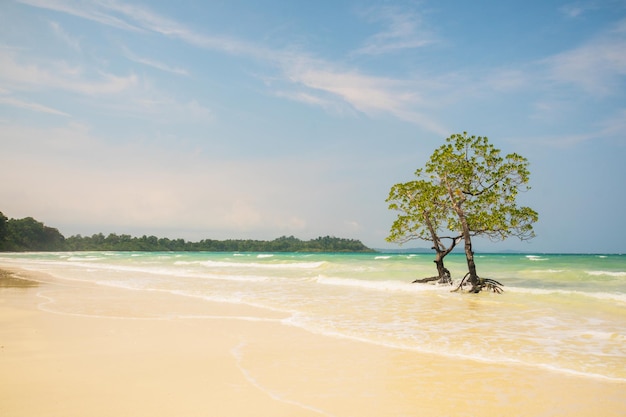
0,212,374,252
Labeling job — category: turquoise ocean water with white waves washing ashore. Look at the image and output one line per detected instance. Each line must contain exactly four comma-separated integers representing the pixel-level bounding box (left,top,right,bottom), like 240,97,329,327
0,252,626,381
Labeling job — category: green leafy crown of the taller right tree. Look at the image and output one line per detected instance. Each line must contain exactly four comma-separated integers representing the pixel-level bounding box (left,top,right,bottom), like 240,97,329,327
418,133,538,240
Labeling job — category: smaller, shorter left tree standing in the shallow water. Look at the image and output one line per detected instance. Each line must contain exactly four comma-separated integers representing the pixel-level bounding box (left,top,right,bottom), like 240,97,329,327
387,180,462,284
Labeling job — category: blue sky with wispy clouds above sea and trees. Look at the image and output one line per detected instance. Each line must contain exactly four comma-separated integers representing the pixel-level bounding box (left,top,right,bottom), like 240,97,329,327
0,0,626,253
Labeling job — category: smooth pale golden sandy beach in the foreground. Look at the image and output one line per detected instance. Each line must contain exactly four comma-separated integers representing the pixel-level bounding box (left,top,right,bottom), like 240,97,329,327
0,266,626,417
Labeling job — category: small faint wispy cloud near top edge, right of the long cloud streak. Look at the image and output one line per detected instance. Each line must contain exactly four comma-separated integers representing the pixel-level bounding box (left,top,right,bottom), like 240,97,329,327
354,7,434,55
